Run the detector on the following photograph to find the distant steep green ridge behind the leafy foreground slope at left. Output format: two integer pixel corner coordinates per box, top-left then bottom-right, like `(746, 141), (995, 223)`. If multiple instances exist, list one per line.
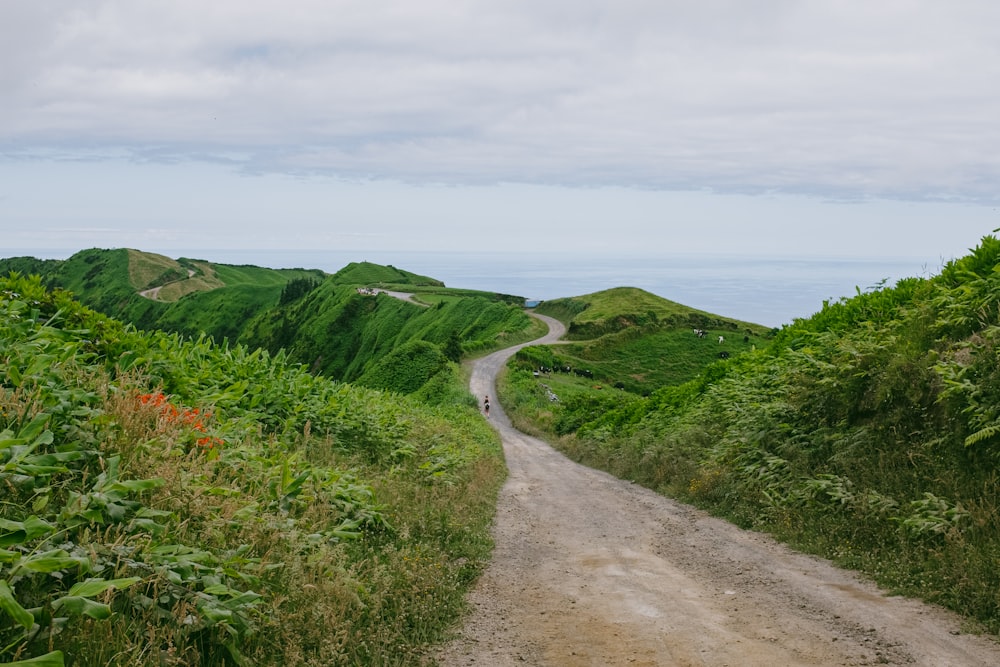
(0, 249), (539, 393)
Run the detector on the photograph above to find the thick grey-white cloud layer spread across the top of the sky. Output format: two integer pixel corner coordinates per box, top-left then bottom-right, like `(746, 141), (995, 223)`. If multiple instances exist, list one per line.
(0, 0), (1000, 201)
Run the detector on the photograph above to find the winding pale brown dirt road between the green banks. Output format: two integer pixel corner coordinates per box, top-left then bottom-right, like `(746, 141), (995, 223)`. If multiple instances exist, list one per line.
(436, 318), (1000, 667)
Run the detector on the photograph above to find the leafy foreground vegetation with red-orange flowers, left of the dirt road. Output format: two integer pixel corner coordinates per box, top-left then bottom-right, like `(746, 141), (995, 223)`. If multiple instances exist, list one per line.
(0, 275), (503, 667)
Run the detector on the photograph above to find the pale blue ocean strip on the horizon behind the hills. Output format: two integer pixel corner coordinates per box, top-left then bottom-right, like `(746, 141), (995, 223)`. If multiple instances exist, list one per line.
(7, 249), (942, 327)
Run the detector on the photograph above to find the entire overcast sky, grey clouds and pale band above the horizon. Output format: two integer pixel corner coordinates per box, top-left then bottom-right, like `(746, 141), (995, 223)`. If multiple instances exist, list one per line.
(0, 0), (1000, 260)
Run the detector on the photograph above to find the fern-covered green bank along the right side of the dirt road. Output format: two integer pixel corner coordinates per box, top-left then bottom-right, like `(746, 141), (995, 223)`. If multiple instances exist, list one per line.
(500, 237), (1000, 632)
